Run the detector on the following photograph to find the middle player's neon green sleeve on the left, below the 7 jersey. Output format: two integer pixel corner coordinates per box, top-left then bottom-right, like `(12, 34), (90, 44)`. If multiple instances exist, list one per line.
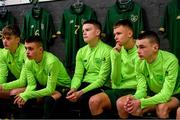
(71, 49), (84, 89)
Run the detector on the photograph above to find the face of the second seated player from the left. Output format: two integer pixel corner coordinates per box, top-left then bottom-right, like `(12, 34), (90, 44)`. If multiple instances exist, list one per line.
(25, 42), (42, 60)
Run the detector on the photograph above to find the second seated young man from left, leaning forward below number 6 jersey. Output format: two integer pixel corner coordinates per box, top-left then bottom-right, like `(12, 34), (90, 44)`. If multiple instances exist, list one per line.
(14, 36), (70, 118)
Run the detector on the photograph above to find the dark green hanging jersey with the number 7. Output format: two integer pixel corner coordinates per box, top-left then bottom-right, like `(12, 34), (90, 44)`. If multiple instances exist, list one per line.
(59, 4), (97, 69)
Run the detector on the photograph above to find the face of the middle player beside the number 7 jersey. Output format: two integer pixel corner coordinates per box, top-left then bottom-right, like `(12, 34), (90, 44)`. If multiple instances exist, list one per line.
(83, 24), (100, 43)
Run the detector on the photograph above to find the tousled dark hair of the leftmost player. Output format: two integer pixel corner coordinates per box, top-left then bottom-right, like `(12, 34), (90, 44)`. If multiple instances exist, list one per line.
(2, 25), (20, 37)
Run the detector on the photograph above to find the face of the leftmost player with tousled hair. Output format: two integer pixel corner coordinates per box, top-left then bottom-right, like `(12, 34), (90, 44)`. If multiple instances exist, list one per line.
(2, 35), (19, 51)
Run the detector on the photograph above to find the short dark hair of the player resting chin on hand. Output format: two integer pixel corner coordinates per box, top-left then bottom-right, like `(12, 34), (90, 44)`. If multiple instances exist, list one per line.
(113, 19), (133, 32)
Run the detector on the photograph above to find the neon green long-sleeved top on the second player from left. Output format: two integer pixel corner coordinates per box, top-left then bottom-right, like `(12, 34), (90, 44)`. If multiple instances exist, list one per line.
(20, 51), (71, 101)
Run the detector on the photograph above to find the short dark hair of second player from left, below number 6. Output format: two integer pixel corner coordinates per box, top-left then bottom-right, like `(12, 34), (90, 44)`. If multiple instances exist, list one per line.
(25, 36), (42, 47)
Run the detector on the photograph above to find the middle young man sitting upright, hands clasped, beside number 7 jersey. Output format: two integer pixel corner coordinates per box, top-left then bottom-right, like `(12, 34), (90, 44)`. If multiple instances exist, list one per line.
(66, 20), (112, 118)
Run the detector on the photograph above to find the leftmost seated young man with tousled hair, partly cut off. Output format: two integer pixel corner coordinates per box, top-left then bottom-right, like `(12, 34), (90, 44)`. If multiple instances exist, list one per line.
(0, 25), (26, 118)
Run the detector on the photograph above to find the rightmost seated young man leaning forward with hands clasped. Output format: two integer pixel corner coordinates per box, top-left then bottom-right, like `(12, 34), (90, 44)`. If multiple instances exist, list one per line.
(118, 31), (179, 118)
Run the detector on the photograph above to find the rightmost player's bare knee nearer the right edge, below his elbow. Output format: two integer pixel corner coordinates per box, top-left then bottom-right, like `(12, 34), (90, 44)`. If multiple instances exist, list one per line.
(156, 103), (169, 118)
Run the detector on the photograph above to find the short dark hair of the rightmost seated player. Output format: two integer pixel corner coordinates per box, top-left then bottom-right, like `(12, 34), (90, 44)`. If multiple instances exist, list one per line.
(137, 31), (160, 47)
